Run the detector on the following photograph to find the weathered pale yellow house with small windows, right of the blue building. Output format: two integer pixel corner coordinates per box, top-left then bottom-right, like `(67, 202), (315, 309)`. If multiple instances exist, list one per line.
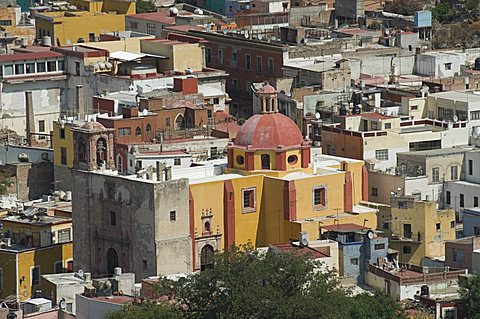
(378, 196), (456, 265)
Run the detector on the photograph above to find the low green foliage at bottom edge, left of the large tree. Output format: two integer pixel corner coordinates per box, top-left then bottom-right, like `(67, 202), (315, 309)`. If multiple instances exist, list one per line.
(105, 302), (182, 319)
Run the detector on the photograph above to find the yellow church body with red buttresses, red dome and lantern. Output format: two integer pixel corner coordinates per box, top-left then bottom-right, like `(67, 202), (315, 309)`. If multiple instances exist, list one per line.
(189, 85), (377, 269)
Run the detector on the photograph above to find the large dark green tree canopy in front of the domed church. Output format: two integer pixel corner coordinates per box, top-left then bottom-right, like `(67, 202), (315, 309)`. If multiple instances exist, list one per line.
(109, 247), (406, 319)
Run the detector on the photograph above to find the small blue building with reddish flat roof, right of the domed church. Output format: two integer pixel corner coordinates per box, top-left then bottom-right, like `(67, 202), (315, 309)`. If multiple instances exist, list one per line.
(321, 224), (388, 283)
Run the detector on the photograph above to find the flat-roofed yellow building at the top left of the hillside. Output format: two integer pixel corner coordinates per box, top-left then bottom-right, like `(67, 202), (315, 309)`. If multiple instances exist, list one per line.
(35, 0), (135, 46)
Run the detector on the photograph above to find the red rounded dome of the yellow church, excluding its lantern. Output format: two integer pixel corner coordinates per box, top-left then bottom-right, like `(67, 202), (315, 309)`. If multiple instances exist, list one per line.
(234, 113), (303, 149)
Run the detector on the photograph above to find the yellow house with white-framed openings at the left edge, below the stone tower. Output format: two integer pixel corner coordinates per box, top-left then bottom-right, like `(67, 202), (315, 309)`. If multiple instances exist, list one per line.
(0, 208), (73, 301)
